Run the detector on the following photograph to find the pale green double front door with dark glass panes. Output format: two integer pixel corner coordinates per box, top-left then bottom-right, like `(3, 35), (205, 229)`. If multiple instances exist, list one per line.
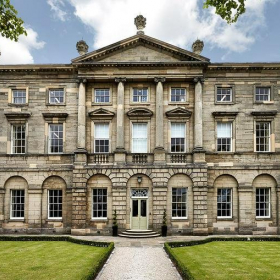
(131, 198), (148, 230)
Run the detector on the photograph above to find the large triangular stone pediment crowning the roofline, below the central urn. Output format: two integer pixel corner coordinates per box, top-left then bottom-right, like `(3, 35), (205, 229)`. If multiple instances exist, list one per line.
(72, 35), (209, 64)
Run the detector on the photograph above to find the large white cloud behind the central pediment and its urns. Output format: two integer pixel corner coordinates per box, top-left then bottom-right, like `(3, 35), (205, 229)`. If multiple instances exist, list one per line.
(64, 0), (275, 55)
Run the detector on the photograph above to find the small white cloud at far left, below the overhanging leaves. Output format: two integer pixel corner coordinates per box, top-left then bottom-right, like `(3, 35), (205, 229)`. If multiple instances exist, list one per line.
(0, 28), (45, 64)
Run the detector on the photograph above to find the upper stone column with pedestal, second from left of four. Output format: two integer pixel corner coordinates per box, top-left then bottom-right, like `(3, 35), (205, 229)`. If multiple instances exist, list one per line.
(115, 78), (126, 163)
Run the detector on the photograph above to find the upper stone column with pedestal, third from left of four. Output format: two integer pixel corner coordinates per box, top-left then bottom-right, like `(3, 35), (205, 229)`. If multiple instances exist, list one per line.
(154, 77), (165, 164)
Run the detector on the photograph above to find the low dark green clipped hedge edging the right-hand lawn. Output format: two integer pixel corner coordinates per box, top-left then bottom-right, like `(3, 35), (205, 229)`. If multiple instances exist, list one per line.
(164, 236), (280, 280)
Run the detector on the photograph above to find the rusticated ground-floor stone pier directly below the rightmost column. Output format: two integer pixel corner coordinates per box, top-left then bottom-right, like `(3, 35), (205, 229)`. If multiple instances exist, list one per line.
(192, 168), (208, 235)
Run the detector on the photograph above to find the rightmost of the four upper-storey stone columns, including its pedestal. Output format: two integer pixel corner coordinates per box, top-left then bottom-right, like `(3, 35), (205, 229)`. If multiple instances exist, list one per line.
(193, 78), (205, 163)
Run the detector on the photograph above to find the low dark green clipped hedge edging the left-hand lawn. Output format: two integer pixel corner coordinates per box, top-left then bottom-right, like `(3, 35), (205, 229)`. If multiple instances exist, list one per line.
(0, 235), (114, 280)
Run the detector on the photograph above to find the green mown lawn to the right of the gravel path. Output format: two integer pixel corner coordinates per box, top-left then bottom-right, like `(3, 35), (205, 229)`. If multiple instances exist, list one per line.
(171, 241), (280, 280)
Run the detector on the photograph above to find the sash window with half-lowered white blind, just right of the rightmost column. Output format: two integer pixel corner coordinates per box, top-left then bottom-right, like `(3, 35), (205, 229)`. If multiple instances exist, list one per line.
(217, 122), (232, 152)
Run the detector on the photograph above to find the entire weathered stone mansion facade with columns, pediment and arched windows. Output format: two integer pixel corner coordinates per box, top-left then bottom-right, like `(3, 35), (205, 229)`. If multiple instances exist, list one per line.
(0, 18), (280, 235)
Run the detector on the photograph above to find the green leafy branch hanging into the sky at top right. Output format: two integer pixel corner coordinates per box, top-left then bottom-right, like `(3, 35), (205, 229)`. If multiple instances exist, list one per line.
(203, 0), (246, 23)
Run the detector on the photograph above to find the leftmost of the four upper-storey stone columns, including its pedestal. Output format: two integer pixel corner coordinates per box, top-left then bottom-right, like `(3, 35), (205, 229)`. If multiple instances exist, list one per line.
(75, 79), (87, 164)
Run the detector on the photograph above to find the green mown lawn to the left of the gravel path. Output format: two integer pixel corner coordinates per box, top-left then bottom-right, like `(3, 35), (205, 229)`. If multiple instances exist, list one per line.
(0, 241), (108, 280)
